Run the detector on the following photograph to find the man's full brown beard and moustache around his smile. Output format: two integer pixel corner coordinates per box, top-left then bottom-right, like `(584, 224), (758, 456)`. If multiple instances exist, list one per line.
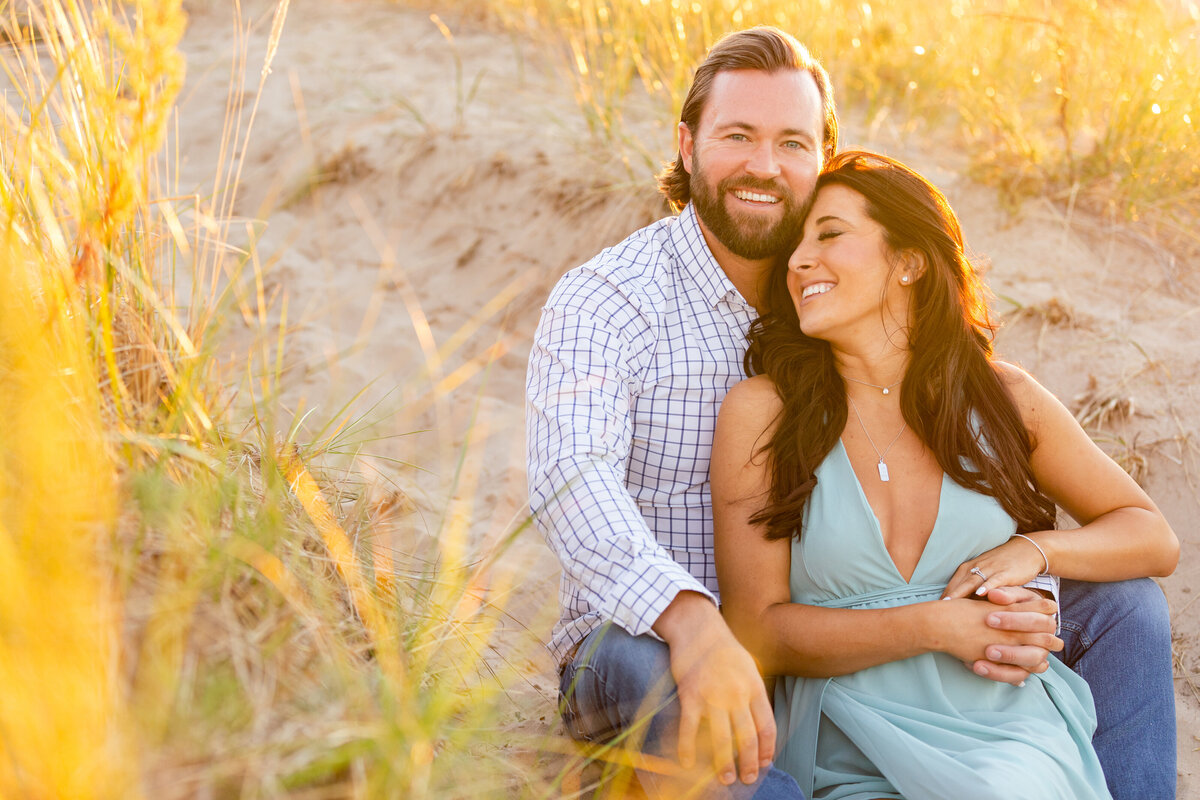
(689, 152), (806, 261)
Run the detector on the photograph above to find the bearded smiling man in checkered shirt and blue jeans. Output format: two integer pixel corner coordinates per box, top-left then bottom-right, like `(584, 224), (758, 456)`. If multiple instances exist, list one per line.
(527, 28), (1175, 798)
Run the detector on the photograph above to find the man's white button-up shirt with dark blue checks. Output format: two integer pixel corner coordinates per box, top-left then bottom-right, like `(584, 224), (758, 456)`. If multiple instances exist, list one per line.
(526, 205), (1057, 662)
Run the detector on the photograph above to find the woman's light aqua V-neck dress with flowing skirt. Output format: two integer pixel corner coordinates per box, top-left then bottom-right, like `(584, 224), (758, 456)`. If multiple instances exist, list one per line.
(775, 440), (1110, 800)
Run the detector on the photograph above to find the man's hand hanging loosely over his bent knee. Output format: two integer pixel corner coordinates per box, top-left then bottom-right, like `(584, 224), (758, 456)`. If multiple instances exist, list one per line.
(654, 591), (775, 786)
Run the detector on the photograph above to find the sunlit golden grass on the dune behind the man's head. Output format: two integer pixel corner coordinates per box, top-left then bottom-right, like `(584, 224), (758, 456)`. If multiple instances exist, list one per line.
(472, 0), (1200, 260)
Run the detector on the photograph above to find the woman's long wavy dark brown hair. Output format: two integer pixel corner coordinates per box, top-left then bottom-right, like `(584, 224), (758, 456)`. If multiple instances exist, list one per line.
(745, 151), (1055, 539)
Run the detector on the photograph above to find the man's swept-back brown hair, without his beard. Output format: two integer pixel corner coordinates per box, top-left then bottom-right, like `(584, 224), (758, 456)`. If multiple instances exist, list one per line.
(659, 25), (838, 211)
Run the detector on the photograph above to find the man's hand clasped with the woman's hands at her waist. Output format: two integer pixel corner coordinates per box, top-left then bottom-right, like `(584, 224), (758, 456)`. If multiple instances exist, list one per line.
(950, 587), (1063, 685)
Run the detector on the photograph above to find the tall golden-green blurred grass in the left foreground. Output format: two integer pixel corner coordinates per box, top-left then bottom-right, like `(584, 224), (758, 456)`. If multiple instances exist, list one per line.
(0, 0), (556, 800)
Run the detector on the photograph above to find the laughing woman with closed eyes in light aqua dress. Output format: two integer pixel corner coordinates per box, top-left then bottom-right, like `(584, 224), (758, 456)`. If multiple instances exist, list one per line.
(712, 152), (1178, 800)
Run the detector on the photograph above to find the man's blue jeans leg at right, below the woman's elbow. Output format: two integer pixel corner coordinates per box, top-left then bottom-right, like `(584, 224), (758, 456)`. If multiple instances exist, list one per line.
(1058, 578), (1176, 800)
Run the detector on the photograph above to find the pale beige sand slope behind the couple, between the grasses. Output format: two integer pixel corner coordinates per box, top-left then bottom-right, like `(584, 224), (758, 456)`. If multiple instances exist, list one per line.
(179, 0), (1200, 798)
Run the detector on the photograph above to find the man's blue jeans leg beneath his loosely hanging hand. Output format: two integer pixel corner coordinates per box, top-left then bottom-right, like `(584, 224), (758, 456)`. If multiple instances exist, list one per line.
(559, 625), (804, 800)
